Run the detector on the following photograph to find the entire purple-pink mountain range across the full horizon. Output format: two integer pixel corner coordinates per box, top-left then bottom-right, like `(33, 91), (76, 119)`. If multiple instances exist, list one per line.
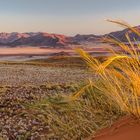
(0, 26), (140, 47)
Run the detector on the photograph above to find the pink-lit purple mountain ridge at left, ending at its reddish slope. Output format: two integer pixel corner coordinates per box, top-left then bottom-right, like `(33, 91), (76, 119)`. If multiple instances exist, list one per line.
(0, 32), (74, 47)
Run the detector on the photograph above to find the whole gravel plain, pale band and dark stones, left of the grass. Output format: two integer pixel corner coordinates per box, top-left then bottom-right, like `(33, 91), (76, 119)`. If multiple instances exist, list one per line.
(0, 64), (92, 140)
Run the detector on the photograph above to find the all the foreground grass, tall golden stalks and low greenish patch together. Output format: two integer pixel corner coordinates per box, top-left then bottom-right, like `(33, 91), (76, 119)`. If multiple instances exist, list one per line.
(26, 21), (140, 140)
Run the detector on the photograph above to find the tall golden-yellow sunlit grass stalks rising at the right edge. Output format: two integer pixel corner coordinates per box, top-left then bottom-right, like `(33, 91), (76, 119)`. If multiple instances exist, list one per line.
(77, 20), (140, 118)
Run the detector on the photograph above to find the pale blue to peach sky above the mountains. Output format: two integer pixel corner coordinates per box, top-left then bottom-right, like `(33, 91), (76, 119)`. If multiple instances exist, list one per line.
(0, 0), (140, 36)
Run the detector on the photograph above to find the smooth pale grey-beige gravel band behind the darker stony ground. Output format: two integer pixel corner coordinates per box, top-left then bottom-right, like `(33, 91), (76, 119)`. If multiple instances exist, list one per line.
(0, 64), (92, 86)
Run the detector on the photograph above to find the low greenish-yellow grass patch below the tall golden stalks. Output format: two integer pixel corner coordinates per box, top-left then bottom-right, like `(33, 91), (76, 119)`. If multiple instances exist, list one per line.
(27, 83), (123, 140)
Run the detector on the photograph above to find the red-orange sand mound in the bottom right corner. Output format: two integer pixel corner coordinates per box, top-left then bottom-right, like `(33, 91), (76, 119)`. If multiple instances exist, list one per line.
(94, 116), (140, 140)
